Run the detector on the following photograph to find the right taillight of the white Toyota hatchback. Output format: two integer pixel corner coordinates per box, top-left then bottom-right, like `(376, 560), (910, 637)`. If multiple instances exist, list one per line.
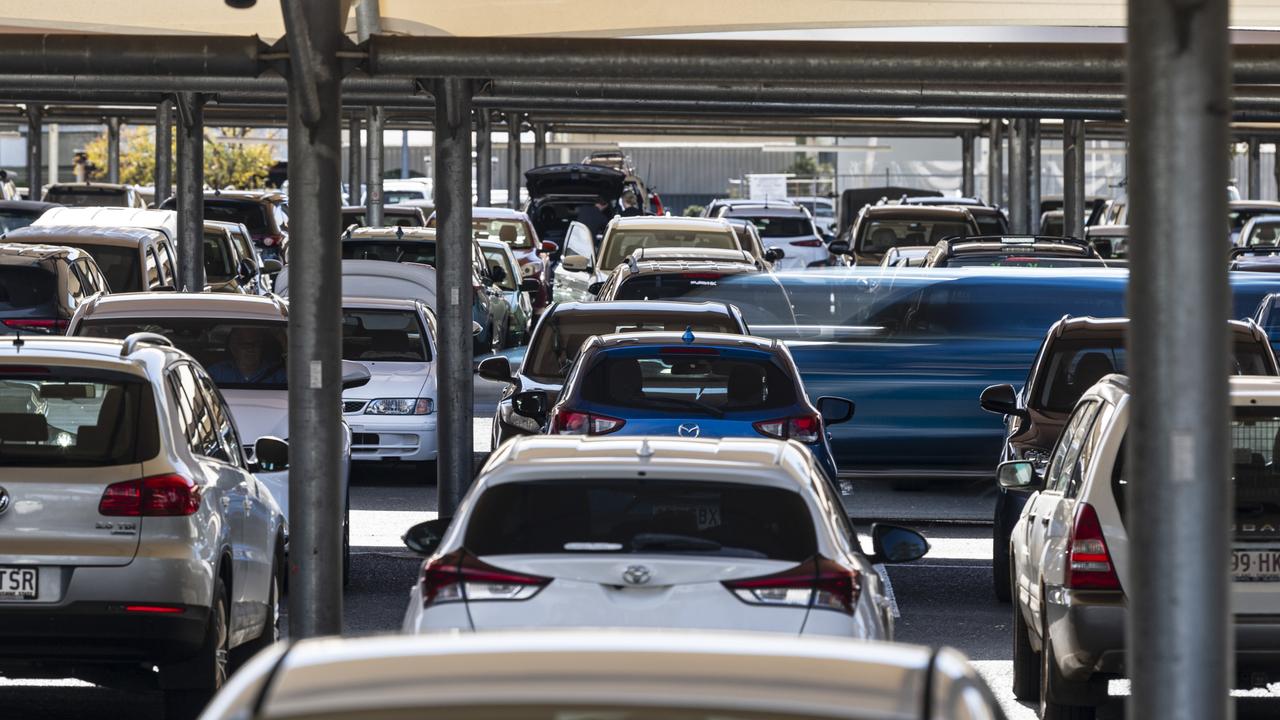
(721, 555), (863, 615)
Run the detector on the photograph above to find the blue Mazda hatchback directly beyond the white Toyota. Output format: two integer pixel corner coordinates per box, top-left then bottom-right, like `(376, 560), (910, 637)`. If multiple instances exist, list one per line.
(512, 331), (854, 482)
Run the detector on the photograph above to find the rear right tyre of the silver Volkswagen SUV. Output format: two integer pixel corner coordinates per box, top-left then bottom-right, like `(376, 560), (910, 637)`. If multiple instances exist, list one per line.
(161, 578), (232, 720)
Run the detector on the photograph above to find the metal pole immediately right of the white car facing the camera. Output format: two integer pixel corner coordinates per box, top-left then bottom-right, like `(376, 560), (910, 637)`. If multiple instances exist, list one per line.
(433, 78), (473, 518)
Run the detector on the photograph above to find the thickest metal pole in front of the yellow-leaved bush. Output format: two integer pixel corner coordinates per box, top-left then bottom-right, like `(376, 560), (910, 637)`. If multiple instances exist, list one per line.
(178, 92), (205, 292)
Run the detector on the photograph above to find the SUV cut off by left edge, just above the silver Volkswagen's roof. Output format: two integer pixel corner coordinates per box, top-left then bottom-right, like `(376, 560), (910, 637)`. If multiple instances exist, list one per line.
(0, 243), (110, 334)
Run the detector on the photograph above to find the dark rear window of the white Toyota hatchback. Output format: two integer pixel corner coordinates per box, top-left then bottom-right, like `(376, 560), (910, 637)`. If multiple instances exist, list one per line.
(463, 478), (817, 561)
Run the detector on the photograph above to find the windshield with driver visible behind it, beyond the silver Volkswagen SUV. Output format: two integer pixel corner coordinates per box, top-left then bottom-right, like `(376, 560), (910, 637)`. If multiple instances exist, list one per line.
(76, 318), (289, 389)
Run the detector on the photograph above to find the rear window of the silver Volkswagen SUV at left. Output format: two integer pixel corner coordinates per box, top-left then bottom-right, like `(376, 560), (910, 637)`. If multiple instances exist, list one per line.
(0, 368), (160, 466)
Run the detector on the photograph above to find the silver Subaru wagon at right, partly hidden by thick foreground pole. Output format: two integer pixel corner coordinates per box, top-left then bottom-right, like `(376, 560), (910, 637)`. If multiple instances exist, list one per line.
(998, 375), (1280, 719)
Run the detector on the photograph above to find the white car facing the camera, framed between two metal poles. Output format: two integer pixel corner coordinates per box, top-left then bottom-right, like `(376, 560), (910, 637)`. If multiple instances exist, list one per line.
(342, 294), (439, 462)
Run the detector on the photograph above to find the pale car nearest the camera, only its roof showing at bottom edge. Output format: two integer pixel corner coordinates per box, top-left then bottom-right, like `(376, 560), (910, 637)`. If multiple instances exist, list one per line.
(205, 630), (1005, 720)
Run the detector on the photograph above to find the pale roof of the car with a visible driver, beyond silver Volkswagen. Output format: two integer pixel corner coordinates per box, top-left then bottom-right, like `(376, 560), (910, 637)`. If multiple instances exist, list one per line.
(81, 292), (289, 320)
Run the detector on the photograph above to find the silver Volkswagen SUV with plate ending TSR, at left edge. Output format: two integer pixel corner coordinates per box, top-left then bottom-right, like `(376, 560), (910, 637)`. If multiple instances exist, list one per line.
(0, 333), (288, 717)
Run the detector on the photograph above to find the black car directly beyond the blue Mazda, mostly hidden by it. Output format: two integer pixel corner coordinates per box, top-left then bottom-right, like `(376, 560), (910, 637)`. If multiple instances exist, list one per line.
(476, 301), (748, 447)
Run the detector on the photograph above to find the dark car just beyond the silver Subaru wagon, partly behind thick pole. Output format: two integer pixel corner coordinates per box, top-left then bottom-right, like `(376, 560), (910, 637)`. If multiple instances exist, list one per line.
(979, 318), (1277, 602)
